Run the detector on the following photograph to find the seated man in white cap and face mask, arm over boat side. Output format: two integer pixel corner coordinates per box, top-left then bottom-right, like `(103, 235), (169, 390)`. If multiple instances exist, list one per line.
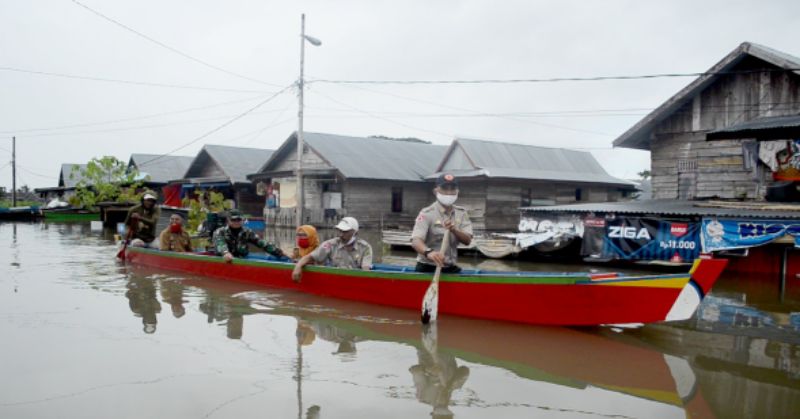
(292, 217), (372, 282)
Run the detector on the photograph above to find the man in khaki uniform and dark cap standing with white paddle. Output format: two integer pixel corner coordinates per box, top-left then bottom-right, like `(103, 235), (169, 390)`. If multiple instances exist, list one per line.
(411, 173), (472, 273)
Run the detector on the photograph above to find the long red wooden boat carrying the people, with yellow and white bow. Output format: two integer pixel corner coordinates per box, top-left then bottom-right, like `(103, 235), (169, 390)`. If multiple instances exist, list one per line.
(126, 247), (727, 325)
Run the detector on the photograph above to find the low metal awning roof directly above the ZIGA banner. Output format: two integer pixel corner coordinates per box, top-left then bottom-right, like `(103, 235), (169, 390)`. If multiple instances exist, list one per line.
(522, 199), (800, 219)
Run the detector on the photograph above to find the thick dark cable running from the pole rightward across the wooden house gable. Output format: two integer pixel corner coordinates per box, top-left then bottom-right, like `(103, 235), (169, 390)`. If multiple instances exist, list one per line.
(306, 68), (800, 84)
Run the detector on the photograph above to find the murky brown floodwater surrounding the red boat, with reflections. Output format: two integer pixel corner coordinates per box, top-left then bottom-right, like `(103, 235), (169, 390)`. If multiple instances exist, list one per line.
(0, 223), (800, 419)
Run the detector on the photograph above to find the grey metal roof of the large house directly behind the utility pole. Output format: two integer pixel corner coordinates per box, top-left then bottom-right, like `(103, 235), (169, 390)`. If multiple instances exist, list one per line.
(303, 132), (447, 182)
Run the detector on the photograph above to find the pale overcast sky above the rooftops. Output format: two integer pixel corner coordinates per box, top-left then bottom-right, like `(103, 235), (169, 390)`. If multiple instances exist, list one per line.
(0, 0), (800, 187)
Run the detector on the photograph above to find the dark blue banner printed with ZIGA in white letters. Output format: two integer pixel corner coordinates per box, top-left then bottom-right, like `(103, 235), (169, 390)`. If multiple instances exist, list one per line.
(603, 217), (700, 262)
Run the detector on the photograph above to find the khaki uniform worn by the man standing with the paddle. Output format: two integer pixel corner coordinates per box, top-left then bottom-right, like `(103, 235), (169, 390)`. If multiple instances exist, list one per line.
(411, 202), (472, 266)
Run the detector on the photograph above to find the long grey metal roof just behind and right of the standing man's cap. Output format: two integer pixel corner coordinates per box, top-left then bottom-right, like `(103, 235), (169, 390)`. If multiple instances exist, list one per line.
(429, 138), (634, 187)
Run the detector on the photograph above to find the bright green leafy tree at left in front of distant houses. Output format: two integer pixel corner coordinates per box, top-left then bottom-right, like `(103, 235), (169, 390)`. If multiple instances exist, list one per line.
(70, 156), (148, 210)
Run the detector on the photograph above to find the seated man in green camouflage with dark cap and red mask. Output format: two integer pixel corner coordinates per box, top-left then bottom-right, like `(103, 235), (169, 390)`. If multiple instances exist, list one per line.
(211, 210), (284, 262)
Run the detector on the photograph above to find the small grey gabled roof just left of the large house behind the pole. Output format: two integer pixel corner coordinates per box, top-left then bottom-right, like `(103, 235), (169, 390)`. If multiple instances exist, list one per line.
(185, 144), (274, 183)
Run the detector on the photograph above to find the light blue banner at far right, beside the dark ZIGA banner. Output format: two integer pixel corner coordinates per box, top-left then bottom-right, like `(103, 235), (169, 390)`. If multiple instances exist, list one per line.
(702, 218), (800, 252)
